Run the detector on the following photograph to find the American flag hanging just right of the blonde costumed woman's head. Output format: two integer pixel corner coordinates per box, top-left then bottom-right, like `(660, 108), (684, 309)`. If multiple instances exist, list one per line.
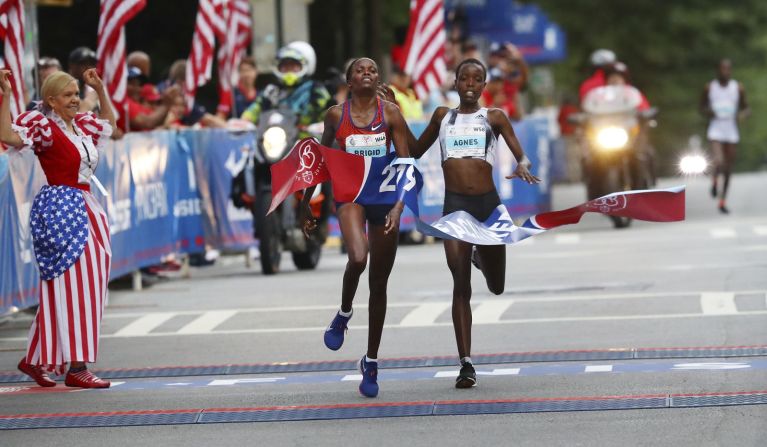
(96, 0), (146, 122)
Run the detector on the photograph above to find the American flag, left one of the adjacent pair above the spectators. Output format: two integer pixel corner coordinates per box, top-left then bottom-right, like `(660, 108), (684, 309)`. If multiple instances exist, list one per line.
(184, 0), (228, 109)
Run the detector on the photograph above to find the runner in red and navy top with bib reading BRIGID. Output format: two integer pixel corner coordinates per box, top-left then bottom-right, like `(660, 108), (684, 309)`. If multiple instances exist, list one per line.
(303, 58), (412, 397)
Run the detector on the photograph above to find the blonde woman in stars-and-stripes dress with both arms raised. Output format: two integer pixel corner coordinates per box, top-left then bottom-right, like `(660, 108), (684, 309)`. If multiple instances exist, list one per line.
(0, 69), (115, 388)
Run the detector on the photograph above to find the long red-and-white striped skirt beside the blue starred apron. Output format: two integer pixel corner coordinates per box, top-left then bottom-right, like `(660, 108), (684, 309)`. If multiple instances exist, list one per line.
(26, 191), (112, 374)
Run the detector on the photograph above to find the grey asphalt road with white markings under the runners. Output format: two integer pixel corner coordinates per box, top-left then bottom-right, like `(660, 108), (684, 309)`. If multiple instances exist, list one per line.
(0, 173), (767, 446)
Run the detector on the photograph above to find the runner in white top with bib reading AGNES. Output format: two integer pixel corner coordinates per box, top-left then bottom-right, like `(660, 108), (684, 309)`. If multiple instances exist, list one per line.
(410, 59), (540, 388)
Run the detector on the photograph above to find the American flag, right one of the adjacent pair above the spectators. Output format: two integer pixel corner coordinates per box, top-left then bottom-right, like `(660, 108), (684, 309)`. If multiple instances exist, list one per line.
(216, 0), (252, 117)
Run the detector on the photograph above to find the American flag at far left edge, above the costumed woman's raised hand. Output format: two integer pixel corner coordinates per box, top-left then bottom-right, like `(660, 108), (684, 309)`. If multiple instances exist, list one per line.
(0, 0), (26, 116)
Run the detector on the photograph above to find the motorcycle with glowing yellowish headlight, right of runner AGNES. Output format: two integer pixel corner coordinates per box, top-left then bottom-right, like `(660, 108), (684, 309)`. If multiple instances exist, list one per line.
(568, 85), (657, 228)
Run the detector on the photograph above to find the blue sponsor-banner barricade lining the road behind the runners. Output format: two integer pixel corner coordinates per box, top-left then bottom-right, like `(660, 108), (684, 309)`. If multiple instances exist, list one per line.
(0, 118), (551, 315)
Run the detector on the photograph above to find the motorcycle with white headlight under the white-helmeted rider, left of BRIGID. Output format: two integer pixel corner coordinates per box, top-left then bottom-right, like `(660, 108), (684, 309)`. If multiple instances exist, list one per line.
(232, 106), (331, 275)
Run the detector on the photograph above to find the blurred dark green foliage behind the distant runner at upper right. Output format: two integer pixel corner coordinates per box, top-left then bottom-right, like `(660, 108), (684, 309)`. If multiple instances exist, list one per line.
(532, 0), (767, 170)
